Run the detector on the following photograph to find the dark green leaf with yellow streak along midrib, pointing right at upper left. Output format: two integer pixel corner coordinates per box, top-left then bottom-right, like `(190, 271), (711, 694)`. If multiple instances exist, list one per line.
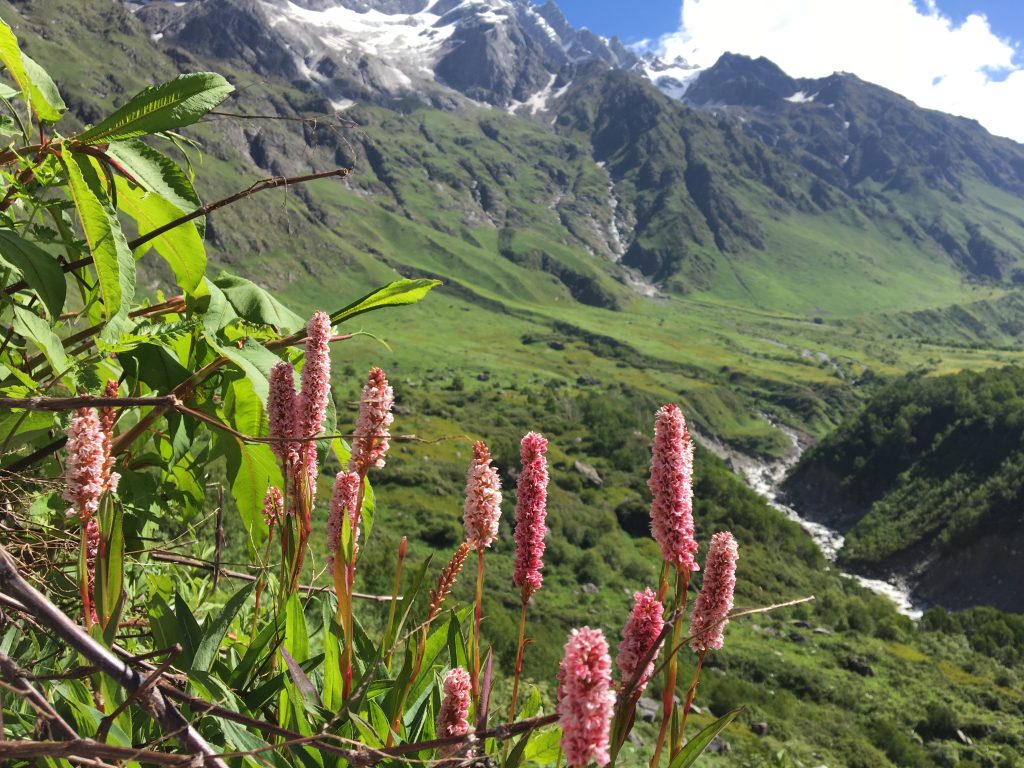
(76, 72), (234, 144)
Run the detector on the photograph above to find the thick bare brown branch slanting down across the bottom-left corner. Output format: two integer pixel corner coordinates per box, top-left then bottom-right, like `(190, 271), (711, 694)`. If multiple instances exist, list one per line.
(0, 547), (227, 768)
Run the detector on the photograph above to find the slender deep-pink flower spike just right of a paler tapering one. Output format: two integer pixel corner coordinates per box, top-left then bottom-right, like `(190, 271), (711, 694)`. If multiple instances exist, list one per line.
(512, 432), (548, 600)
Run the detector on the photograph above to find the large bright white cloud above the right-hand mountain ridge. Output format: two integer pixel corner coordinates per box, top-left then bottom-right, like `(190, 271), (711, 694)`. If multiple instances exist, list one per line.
(656, 0), (1024, 141)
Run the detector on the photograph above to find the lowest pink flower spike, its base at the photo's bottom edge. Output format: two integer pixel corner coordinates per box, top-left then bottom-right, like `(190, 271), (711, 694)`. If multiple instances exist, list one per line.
(558, 627), (615, 768)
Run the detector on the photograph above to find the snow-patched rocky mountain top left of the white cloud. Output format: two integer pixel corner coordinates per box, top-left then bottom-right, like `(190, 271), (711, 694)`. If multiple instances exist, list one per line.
(129, 0), (641, 112)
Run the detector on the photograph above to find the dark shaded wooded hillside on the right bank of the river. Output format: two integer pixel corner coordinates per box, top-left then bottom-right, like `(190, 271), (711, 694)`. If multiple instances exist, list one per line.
(786, 368), (1024, 611)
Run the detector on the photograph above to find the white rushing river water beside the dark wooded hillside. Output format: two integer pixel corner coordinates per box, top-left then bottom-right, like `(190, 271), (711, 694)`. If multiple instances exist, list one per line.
(701, 424), (927, 621)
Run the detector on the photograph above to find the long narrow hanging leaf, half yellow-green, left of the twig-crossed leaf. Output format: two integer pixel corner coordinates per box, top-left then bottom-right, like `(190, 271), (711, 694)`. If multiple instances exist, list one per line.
(61, 153), (135, 318)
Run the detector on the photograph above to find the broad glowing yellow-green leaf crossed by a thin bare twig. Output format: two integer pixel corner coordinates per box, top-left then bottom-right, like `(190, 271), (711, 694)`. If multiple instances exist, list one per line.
(115, 176), (206, 293)
